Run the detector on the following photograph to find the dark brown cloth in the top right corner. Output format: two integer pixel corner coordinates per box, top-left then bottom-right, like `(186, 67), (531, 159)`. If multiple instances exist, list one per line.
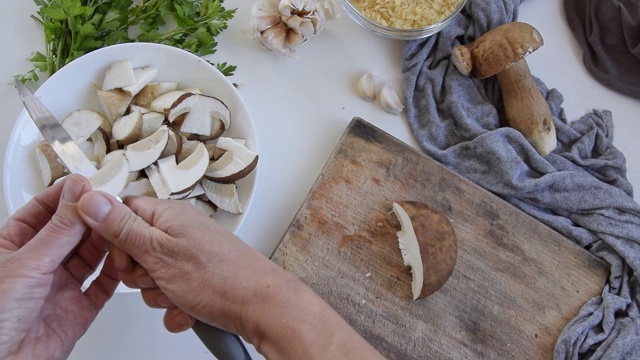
(564, 0), (640, 99)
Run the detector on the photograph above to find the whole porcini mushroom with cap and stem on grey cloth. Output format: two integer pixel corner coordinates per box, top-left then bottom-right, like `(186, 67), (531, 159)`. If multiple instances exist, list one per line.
(451, 22), (557, 156)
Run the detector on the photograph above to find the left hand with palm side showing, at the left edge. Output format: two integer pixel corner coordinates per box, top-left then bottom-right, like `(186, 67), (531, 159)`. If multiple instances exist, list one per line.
(0, 175), (119, 359)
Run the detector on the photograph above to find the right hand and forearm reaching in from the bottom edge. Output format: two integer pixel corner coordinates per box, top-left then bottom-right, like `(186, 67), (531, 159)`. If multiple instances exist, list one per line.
(78, 191), (382, 360)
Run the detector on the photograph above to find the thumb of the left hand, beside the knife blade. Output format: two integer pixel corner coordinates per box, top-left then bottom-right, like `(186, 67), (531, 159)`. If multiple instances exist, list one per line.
(20, 175), (91, 271)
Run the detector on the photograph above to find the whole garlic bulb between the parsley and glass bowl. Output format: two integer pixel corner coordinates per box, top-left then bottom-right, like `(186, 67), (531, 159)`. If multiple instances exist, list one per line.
(251, 0), (336, 56)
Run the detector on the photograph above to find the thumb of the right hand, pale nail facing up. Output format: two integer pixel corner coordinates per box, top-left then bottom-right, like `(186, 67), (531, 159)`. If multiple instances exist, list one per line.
(78, 191), (164, 266)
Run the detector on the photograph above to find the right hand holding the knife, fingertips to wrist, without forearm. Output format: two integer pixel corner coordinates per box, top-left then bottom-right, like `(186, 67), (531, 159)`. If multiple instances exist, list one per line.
(79, 192), (286, 335)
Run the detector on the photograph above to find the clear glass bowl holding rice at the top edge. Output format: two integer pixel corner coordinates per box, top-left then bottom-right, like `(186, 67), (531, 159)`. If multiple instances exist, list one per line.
(339, 0), (467, 40)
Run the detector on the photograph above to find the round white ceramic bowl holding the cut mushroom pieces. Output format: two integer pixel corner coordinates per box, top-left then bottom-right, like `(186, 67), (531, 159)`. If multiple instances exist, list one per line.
(3, 43), (259, 290)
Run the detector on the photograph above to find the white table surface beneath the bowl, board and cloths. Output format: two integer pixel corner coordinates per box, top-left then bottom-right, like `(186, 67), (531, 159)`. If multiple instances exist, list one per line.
(0, 0), (640, 360)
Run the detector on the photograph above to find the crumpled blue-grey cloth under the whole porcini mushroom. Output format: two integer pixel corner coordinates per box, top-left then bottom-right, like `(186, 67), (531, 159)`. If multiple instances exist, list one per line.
(402, 0), (640, 359)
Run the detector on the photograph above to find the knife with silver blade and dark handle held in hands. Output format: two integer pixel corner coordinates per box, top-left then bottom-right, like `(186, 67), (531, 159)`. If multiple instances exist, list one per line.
(15, 78), (251, 360)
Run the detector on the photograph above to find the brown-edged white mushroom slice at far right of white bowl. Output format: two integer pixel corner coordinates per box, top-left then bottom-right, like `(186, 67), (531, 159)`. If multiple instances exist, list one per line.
(205, 137), (258, 184)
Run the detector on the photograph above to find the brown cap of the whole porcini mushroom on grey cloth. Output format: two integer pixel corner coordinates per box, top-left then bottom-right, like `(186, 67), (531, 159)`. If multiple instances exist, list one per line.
(452, 22), (544, 79)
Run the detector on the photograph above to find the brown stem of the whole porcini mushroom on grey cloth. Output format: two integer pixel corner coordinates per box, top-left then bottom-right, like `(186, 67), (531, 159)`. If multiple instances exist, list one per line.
(497, 58), (557, 156)
